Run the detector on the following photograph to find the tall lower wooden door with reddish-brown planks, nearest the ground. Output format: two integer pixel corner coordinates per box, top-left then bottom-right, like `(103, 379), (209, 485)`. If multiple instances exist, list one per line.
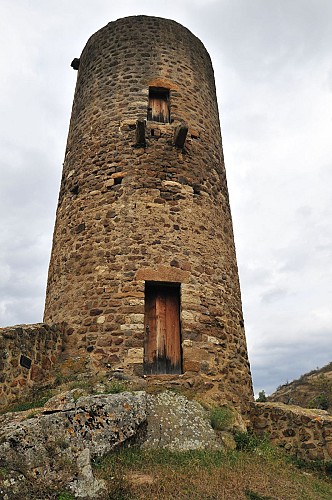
(144, 284), (181, 374)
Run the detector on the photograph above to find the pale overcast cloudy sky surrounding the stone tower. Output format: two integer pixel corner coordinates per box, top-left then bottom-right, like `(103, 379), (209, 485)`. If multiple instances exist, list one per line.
(0, 0), (332, 393)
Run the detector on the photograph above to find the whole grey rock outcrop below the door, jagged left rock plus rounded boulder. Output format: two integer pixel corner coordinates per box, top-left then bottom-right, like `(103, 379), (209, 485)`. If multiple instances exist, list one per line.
(0, 389), (220, 500)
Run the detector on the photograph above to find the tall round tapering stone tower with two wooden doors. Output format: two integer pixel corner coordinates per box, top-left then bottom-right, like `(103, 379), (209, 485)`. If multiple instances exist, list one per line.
(44, 16), (252, 404)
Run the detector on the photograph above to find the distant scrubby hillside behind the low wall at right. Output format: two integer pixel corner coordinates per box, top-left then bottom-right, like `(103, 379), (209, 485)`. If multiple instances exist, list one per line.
(267, 362), (332, 414)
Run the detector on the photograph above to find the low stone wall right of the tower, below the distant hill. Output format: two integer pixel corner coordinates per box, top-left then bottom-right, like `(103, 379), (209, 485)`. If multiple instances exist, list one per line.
(250, 403), (332, 461)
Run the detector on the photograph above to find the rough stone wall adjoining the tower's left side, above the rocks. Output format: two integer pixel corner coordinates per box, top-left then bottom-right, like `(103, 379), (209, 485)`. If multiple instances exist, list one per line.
(0, 323), (64, 408)
